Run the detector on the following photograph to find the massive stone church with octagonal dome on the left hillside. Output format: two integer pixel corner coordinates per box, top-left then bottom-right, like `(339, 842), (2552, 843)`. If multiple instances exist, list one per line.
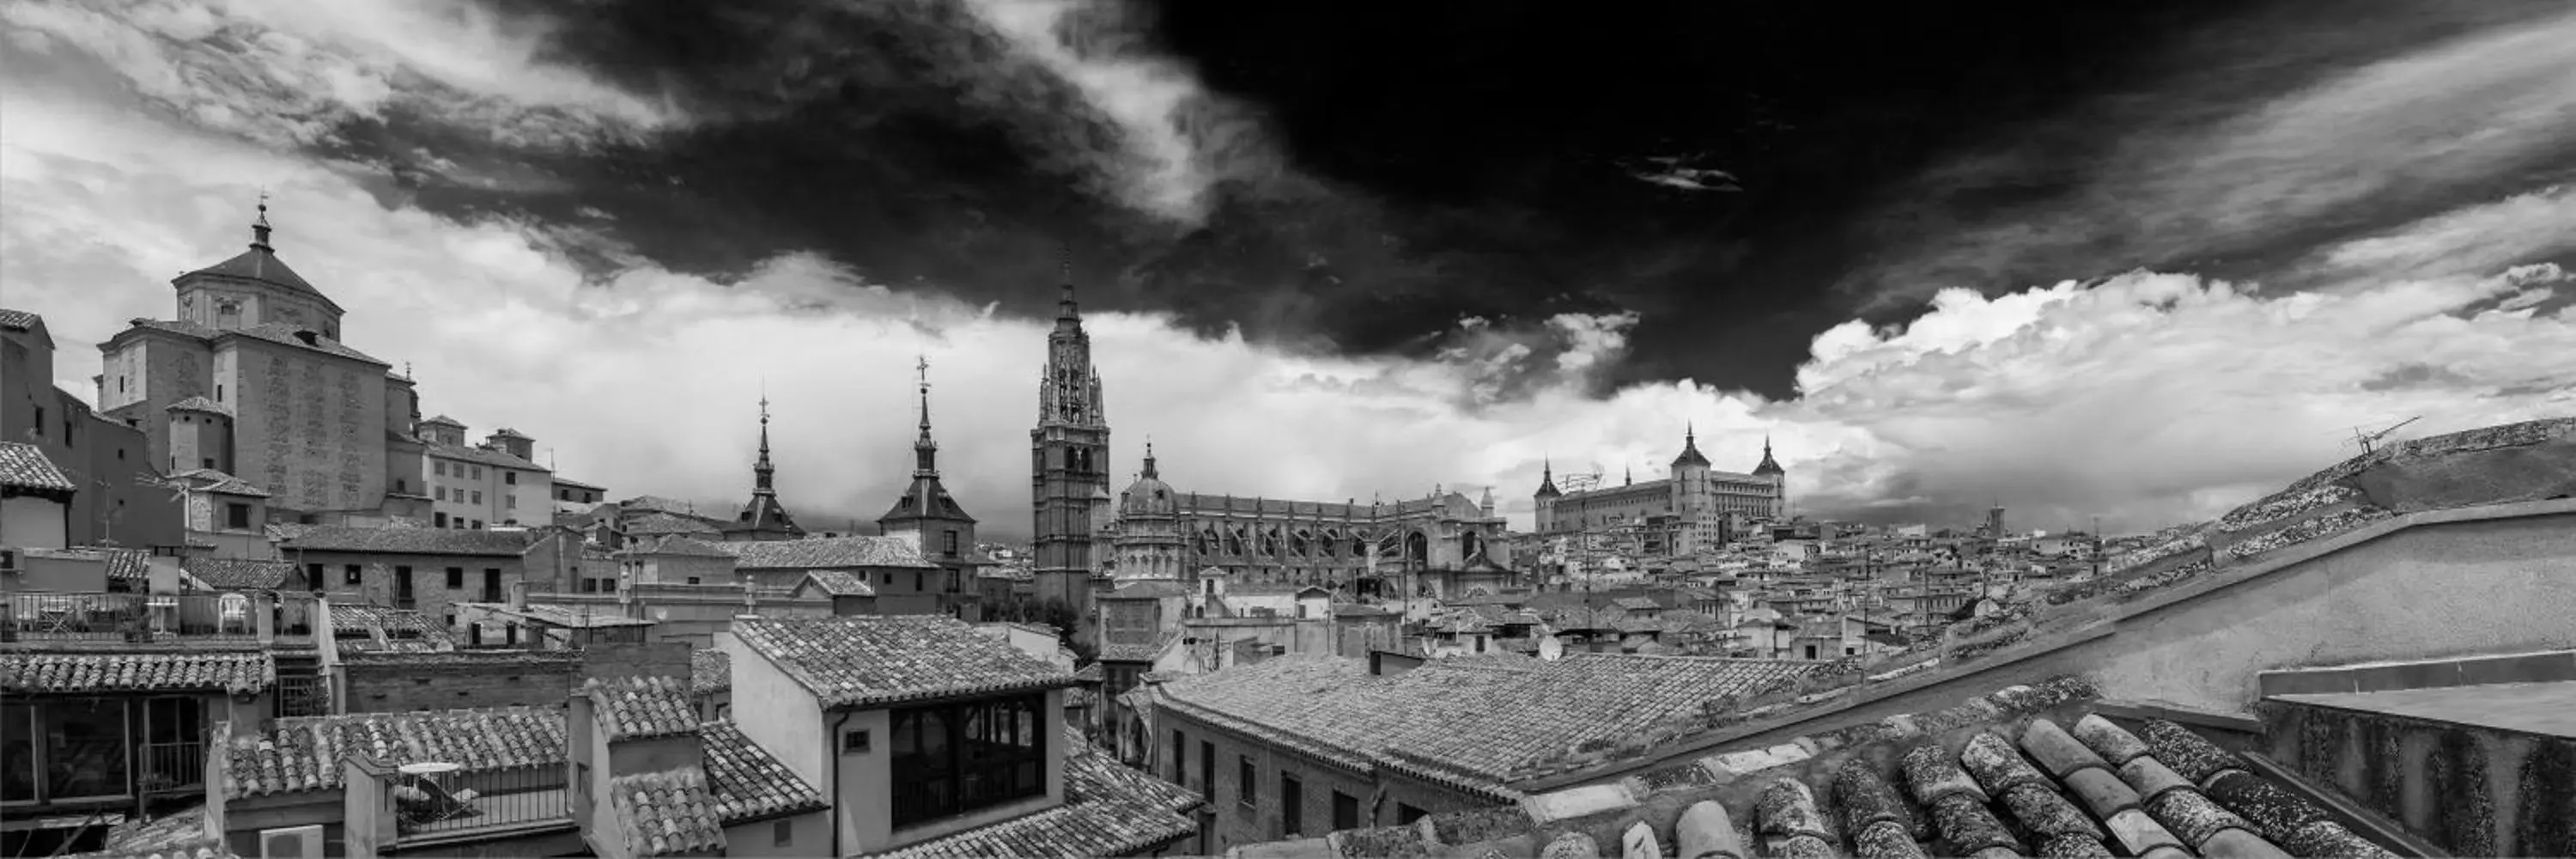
(95, 204), (580, 529)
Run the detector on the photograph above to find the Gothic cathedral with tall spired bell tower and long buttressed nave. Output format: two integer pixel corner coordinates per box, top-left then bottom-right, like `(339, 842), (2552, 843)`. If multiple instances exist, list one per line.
(1030, 260), (1510, 604)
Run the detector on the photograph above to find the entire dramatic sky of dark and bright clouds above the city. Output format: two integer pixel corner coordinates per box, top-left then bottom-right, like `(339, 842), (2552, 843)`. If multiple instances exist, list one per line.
(0, 0), (2576, 537)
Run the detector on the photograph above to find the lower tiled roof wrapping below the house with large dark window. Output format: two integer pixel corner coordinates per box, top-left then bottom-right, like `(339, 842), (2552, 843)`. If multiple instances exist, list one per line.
(881, 730), (1200, 859)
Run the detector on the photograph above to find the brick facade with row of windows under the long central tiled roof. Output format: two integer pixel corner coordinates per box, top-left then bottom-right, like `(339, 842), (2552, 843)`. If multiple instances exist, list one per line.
(1151, 710), (1497, 854)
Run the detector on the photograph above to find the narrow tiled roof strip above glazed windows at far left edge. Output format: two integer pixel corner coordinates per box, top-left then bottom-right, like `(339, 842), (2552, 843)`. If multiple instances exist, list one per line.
(0, 650), (278, 694)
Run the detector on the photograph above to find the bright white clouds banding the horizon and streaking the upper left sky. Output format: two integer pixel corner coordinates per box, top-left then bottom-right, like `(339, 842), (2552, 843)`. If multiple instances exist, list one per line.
(0, 3), (2576, 534)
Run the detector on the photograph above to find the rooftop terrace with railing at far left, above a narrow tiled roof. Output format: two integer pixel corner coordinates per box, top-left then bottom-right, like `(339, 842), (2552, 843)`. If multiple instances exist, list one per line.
(0, 591), (317, 643)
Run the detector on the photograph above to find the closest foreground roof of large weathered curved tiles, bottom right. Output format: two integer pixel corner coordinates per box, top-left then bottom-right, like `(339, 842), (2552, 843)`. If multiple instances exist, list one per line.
(1288, 679), (2391, 859)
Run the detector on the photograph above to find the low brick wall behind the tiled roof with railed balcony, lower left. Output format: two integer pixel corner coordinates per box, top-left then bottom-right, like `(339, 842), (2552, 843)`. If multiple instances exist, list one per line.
(345, 650), (580, 712)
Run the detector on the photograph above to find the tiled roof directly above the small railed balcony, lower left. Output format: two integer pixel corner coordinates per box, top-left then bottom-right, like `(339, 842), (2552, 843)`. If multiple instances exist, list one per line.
(224, 707), (564, 797)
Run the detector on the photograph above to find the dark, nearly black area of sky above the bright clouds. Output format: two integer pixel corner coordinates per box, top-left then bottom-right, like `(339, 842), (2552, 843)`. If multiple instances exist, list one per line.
(282, 0), (2318, 394)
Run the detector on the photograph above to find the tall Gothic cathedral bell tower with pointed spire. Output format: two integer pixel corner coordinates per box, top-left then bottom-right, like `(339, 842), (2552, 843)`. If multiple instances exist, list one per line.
(1028, 250), (1110, 612)
